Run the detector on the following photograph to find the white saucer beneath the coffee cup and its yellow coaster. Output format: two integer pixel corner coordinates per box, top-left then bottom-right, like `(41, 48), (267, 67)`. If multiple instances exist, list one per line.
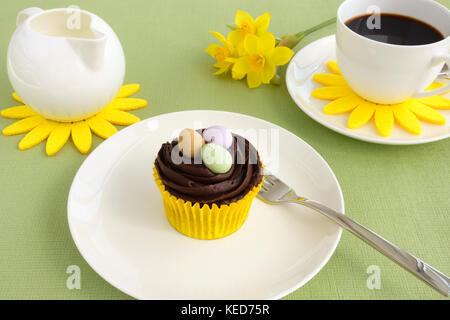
(286, 35), (450, 145)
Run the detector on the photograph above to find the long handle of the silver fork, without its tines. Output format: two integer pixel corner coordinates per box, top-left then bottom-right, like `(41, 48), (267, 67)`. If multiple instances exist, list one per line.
(296, 199), (450, 297)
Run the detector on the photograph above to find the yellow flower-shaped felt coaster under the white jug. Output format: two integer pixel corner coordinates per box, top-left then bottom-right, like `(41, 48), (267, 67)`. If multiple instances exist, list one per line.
(0, 84), (147, 156)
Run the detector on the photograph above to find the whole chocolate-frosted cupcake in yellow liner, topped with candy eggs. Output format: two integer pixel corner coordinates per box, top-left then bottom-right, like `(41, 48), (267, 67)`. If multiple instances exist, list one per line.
(153, 126), (263, 239)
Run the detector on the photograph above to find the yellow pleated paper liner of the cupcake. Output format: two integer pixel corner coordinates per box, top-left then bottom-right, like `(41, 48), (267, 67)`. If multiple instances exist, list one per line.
(153, 168), (262, 240)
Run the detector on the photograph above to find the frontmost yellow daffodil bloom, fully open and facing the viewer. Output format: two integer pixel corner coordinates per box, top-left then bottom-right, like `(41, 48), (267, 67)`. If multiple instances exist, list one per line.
(226, 32), (294, 88)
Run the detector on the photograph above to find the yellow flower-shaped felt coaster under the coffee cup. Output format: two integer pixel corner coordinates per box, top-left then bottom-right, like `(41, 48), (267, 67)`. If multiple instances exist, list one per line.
(311, 61), (450, 137)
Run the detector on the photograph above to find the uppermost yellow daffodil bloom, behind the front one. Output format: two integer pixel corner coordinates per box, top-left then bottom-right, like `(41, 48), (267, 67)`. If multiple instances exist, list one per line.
(229, 10), (270, 55)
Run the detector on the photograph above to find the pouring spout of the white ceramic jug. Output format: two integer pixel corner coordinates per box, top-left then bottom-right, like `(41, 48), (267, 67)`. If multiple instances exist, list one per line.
(67, 31), (106, 71)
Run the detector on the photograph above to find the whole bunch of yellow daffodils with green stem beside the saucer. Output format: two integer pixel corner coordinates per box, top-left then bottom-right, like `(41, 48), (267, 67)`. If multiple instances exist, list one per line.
(206, 10), (336, 88)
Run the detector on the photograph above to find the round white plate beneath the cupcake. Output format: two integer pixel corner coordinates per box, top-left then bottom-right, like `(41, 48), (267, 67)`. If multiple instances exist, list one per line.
(68, 111), (344, 299)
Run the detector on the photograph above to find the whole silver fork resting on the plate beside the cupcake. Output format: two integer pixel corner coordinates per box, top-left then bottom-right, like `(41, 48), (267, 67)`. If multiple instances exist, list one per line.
(257, 174), (450, 297)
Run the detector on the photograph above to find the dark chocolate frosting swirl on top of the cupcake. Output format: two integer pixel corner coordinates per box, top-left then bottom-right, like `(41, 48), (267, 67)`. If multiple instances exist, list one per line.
(155, 129), (262, 206)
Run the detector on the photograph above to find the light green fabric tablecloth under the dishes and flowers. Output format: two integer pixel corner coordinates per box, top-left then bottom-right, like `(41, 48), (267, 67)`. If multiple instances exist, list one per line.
(0, 0), (450, 299)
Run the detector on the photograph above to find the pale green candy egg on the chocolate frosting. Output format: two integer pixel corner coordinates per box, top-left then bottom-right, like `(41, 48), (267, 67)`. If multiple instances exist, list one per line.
(202, 143), (233, 173)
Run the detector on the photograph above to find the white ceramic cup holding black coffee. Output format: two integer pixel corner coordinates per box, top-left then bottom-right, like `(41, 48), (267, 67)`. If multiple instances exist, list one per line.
(336, 0), (450, 104)
